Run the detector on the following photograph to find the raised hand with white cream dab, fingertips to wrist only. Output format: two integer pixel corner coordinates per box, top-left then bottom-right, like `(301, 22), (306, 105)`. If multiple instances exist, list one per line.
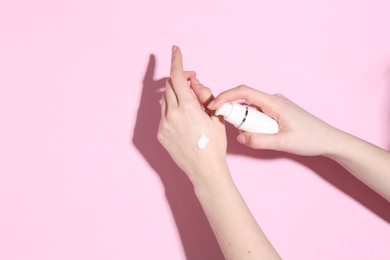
(157, 46), (227, 184)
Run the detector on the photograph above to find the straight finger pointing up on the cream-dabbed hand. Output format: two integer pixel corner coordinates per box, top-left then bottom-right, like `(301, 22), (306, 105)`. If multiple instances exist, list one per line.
(170, 46), (195, 103)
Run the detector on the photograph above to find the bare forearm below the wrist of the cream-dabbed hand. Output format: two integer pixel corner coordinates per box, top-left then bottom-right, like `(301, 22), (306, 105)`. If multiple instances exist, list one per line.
(194, 162), (280, 259)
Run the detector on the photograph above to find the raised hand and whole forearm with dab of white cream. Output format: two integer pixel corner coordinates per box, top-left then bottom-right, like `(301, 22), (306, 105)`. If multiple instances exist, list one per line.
(158, 47), (280, 259)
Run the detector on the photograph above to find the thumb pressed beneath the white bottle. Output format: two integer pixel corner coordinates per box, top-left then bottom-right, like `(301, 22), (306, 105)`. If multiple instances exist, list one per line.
(237, 132), (279, 150)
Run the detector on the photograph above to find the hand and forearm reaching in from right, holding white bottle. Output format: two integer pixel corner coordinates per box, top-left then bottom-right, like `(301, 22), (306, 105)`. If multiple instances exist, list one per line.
(208, 86), (390, 201)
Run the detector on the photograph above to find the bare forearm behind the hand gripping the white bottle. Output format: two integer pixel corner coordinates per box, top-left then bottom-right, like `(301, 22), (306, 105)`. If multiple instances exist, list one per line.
(325, 130), (390, 201)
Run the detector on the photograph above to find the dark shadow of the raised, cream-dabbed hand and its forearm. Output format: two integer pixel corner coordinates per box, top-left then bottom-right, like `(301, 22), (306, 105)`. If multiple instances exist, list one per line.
(132, 55), (224, 260)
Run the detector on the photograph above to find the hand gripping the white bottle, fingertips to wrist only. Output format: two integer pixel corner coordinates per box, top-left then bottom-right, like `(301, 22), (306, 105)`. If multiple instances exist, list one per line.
(208, 85), (339, 156)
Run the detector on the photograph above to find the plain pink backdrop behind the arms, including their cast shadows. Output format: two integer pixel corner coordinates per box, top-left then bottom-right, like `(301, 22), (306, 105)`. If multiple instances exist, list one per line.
(0, 0), (390, 260)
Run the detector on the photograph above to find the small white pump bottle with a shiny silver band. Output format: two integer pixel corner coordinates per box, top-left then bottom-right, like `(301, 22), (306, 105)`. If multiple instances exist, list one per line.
(215, 103), (279, 134)
